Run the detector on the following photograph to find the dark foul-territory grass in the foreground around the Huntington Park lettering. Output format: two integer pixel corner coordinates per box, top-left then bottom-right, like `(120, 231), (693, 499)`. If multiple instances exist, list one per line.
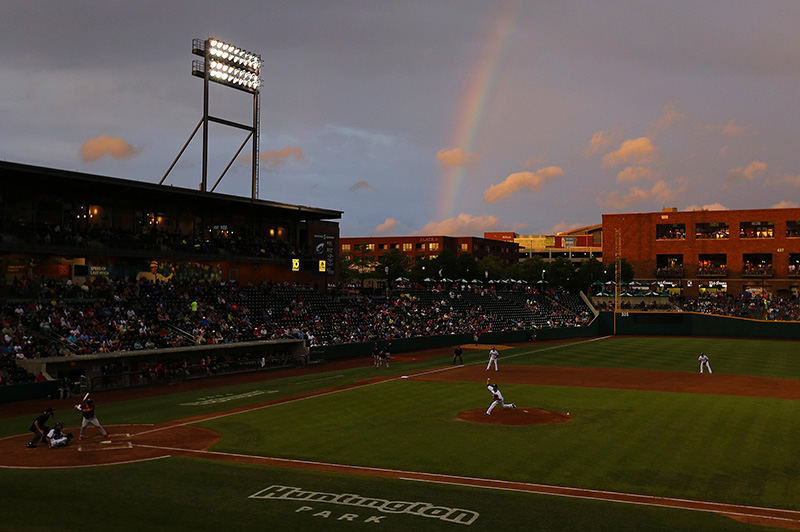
(0, 458), (768, 532)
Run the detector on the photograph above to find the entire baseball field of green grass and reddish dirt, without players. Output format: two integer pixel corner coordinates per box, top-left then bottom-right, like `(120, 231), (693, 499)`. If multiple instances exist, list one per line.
(0, 337), (800, 532)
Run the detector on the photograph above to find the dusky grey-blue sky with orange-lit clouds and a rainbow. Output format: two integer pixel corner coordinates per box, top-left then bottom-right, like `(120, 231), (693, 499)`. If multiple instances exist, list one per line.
(0, 0), (800, 236)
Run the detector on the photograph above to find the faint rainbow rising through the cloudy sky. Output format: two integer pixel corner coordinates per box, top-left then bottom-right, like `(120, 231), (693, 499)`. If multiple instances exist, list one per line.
(436, 0), (520, 220)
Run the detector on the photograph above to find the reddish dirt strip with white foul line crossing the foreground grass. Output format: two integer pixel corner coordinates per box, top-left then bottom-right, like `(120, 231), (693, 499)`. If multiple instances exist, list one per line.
(136, 444), (800, 523)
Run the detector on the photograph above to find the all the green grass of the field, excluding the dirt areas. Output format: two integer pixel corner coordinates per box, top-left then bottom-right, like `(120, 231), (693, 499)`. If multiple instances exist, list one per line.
(0, 338), (800, 531)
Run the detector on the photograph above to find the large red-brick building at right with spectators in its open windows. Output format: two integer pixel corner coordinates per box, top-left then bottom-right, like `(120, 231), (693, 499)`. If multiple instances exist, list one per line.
(603, 208), (800, 296)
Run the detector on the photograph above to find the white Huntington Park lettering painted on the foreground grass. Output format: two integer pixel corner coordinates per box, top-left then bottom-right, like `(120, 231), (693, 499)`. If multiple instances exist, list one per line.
(249, 486), (480, 525)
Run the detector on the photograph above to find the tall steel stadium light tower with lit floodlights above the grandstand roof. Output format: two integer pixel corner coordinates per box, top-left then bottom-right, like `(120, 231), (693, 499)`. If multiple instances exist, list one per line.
(159, 37), (262, 199)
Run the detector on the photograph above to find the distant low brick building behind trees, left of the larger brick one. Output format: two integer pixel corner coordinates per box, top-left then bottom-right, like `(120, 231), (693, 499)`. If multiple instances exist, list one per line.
(339, 236), (519, 266)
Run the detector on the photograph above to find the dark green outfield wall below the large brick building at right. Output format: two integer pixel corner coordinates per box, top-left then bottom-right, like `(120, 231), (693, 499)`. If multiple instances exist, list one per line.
(596, 311), (800, 339)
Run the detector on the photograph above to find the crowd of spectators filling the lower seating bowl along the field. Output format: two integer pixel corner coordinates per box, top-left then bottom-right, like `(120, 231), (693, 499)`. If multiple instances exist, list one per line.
(0, 277), (590, 382)
